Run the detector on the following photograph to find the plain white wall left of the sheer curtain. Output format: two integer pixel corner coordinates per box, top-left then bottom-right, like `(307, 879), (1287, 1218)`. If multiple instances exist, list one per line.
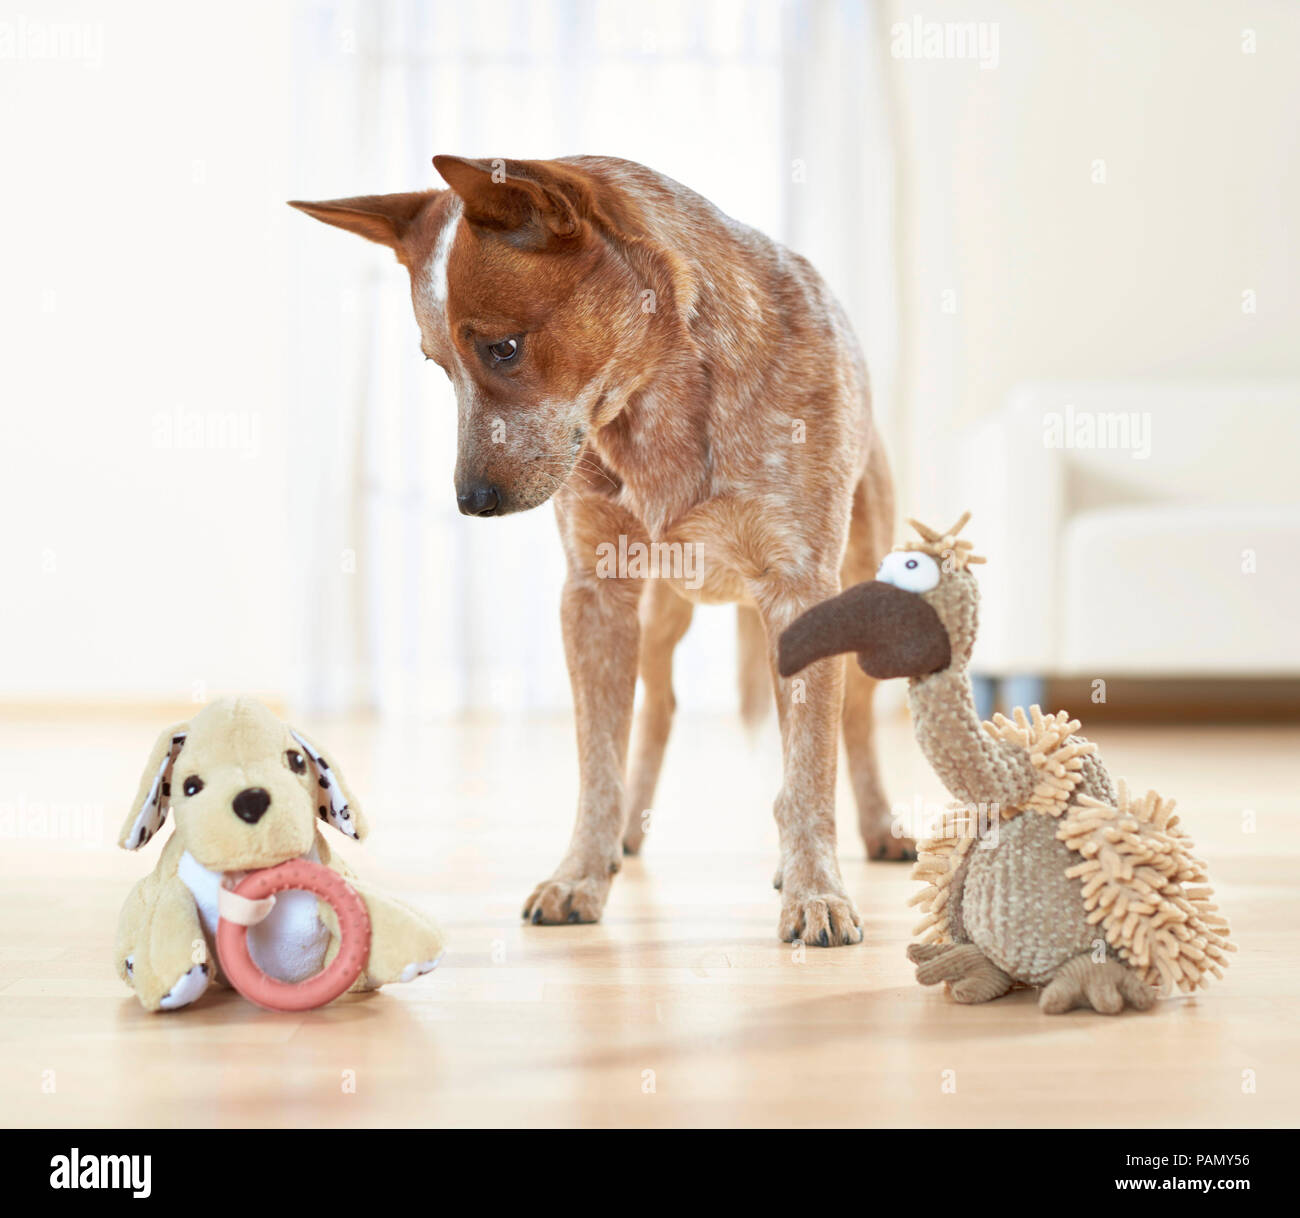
(0, 0), (302, 702)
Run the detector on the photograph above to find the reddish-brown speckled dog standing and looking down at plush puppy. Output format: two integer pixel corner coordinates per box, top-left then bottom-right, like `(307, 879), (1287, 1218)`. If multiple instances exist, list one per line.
(293, 156), (913, 946)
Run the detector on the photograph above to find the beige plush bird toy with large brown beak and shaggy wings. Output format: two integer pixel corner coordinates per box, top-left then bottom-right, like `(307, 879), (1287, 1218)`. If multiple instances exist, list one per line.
(780, 512), (1235, 1014)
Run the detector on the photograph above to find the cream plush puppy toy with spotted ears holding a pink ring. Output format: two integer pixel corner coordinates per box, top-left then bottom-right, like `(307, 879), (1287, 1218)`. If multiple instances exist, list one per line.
(114, 698), (442, 1011)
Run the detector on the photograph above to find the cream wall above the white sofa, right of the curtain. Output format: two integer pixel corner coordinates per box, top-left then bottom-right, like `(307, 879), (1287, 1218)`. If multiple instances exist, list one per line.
(885, 0), (1300, 517)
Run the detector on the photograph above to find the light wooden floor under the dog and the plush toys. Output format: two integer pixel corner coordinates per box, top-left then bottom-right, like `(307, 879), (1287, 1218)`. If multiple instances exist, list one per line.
(0, 716), (1300, 1127)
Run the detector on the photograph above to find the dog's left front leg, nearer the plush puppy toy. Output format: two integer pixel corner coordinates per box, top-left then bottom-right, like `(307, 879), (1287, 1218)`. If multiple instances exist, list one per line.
(524, 569), (642, 924)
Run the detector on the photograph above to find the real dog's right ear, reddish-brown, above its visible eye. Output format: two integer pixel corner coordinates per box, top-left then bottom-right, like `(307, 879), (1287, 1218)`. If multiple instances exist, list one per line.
(433, 156), (581, 246)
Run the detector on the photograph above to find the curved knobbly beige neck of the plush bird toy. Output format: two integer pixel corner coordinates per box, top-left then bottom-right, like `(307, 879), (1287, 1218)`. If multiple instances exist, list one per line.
(907, 667), (1035, 809)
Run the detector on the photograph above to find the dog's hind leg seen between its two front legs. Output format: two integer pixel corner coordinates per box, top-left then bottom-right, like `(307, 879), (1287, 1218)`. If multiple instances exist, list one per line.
(623, 580), (694, 854)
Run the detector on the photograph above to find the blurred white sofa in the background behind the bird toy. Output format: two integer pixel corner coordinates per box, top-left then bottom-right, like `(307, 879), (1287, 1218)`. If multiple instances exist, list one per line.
(954, 374), (1300, 705)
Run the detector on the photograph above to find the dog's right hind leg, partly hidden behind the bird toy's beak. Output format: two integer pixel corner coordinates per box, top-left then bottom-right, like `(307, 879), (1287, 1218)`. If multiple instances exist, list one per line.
(840, 443), (917, 859)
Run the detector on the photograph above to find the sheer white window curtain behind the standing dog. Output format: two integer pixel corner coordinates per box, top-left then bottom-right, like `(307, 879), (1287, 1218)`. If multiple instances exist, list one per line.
(291, 0), (894, 715)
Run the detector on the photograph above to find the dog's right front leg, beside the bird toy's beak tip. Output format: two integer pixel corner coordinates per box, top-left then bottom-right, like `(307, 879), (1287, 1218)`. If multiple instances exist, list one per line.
(757, 582), (862, 948)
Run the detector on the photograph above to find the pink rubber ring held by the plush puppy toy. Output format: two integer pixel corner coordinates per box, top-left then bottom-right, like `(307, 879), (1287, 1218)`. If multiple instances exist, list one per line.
(217, 858), (371, 1011)
